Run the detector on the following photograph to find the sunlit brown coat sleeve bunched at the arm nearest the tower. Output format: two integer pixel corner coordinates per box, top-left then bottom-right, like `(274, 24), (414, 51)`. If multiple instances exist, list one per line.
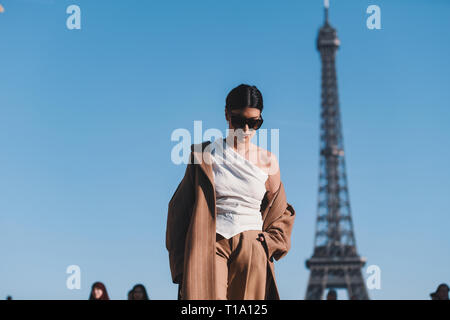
(262, 203), (295, 261)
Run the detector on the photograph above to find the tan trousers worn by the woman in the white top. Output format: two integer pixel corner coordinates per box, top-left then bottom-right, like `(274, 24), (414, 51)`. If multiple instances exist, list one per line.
(215, 230), (267, 300)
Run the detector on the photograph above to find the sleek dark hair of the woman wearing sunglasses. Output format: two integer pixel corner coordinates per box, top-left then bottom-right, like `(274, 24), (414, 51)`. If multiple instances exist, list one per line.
(225, 84), (264, 112)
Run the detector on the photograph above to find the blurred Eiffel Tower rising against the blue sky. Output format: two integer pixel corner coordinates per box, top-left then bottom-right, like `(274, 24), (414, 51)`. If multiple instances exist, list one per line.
(305, 0), (369, 300)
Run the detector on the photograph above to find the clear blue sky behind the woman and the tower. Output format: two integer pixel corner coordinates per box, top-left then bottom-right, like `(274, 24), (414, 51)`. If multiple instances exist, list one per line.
(0, 0), (450, 299)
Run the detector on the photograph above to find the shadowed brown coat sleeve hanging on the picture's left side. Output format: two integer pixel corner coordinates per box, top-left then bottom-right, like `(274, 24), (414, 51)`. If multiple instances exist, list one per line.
(166, 153), (195, 284)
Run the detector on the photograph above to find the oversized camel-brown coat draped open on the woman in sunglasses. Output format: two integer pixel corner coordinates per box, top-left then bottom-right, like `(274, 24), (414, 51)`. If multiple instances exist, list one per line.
(166, 141), (295, 300)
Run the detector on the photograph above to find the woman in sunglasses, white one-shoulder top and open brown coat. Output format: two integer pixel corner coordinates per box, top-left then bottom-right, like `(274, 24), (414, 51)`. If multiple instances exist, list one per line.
(166, 84), (295, 300)
